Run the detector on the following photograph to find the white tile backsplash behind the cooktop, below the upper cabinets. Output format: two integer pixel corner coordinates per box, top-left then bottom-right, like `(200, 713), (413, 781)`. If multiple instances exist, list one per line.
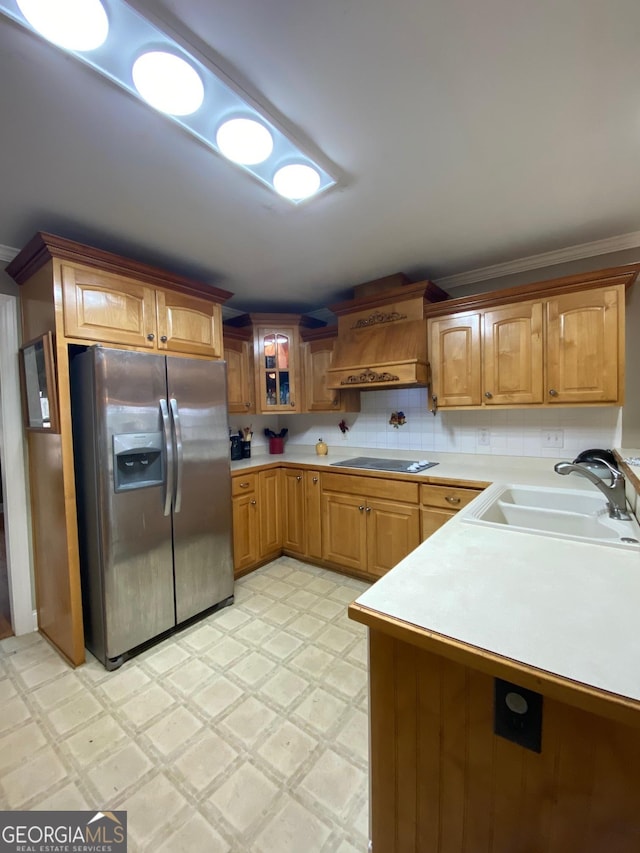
(278, 388), (622, 459)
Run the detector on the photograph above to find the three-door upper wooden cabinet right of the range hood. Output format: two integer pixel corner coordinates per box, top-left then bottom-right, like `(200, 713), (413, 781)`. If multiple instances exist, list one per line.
(427, 264), (640, 409)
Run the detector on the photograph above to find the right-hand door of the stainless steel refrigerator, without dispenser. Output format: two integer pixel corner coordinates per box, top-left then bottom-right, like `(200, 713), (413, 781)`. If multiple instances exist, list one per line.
(167, 356), (233, 623)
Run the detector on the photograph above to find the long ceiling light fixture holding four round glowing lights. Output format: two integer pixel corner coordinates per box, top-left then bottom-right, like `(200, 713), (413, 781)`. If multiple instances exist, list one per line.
(0, 0), (336, 204)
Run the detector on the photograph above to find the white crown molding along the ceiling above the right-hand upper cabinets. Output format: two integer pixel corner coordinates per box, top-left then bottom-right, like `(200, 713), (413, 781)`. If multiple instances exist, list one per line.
(434, 231), (640, 290)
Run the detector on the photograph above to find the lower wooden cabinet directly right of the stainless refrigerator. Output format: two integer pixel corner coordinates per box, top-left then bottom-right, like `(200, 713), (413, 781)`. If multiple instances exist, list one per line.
(231, 468), (282, 577)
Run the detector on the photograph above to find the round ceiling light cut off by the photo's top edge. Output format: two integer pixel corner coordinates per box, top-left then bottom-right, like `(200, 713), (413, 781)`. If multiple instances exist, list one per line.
(17, 0), (109, 52)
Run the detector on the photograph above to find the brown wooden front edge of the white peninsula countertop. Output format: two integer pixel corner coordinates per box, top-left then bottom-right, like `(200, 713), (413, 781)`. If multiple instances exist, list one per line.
(348, 601), (640, 728)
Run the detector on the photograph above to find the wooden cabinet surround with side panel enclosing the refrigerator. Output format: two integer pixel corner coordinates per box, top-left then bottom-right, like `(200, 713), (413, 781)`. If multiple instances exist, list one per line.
(7, 233), (231, 665)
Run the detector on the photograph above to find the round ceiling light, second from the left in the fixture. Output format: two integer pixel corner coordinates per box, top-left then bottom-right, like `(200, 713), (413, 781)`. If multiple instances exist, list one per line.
(132, 50), (204, 116)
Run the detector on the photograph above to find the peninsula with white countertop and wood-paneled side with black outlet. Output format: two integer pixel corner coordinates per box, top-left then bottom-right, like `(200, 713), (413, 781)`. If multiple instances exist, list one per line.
(349, 486), (640, 853)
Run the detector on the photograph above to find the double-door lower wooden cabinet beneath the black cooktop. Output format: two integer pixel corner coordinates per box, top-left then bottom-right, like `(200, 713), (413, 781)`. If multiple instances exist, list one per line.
(322, 473), (420, 578)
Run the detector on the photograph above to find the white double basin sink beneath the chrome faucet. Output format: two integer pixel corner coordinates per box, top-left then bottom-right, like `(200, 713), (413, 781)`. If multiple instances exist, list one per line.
(459, 483), (640, 550)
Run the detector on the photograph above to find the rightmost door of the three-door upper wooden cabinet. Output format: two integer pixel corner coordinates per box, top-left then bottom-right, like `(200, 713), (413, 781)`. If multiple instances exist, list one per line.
(546, 285), (624, 405)
